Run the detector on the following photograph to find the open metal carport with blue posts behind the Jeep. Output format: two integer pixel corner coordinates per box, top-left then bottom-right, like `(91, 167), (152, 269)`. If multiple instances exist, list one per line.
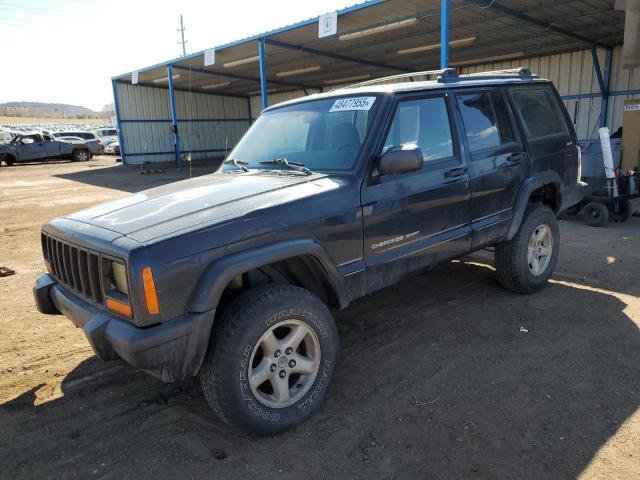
(112, 0), (640, 168)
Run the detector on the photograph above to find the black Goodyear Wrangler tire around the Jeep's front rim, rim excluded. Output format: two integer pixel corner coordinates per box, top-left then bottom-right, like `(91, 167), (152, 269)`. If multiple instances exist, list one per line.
(199, 284), (338, 435)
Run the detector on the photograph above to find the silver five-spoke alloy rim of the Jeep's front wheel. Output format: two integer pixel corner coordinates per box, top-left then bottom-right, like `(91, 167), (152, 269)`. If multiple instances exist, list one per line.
(247, 319), (320, 408)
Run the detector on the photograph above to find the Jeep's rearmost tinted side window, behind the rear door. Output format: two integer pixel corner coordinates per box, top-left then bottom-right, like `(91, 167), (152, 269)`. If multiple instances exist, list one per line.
(511, 88), (567, 140)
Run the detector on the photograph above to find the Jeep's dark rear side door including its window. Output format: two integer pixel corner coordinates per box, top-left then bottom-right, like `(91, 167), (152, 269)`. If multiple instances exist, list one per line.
(456, 87), (530, 248)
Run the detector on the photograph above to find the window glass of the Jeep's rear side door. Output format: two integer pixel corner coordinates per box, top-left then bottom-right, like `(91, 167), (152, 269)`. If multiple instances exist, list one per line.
(456, 91), (515, 152)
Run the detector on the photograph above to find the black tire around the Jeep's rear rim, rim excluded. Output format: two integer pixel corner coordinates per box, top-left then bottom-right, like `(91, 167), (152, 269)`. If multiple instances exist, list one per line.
(495, 205), (560, 293)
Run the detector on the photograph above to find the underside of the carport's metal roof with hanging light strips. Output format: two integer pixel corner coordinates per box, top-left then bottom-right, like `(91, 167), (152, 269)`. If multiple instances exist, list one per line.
(114, 0), (624, 96)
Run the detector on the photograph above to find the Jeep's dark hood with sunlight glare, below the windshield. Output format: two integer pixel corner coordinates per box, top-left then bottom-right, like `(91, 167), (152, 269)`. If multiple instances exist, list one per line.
(67, 170), (338, 243)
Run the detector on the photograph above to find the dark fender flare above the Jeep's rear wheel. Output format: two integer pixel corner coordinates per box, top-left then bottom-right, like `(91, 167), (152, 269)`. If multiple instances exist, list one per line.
(505, 170), (562, 240)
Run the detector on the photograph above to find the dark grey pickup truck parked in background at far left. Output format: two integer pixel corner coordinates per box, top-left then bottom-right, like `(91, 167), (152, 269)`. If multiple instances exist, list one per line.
(0, 132), (91, 166)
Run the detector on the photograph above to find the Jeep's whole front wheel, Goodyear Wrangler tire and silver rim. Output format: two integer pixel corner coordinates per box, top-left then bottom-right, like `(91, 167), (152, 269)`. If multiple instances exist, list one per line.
(200, 284), (338, 435)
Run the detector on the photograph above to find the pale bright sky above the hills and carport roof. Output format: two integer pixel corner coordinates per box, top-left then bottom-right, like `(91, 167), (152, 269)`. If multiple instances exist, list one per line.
(0, 0), (361, 110)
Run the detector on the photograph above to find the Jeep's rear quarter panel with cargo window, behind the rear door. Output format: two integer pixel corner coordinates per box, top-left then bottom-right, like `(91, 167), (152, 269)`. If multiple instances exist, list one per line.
(509, 84), (578, 185)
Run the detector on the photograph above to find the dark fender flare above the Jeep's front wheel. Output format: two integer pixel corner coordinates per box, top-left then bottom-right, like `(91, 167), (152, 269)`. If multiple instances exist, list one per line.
(188, 239), (348, 313)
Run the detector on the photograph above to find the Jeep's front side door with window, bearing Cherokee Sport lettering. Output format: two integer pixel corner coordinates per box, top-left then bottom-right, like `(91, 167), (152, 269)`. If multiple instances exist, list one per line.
(361, 93), (471, 291)
